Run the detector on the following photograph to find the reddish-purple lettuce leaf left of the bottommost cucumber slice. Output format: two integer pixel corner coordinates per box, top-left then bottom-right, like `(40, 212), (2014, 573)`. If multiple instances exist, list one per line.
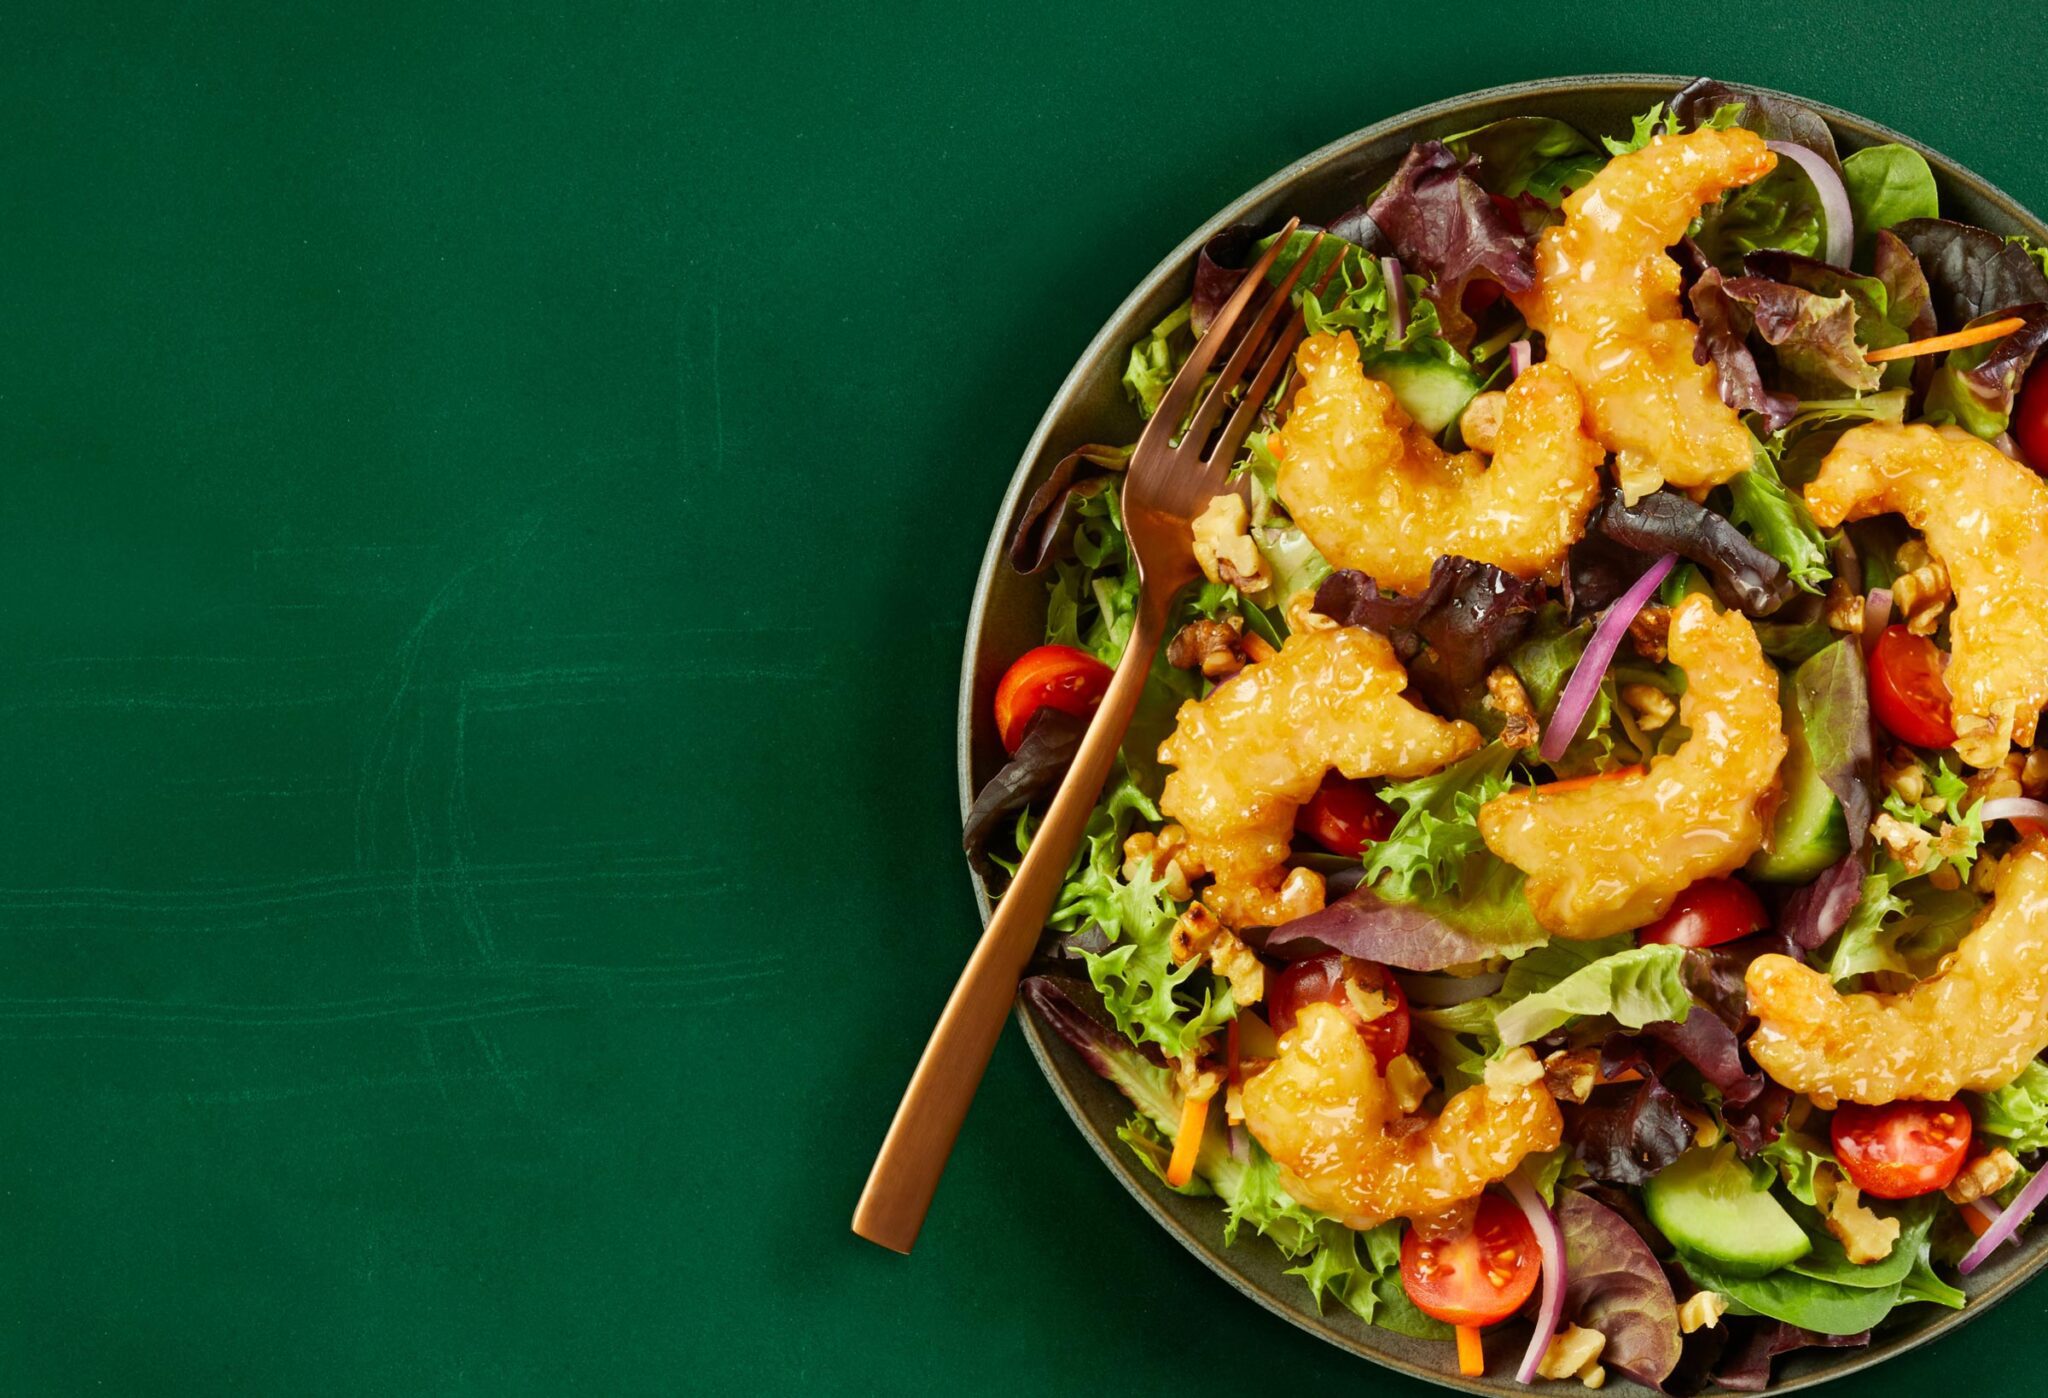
(1556, 1189), (1679, 1388)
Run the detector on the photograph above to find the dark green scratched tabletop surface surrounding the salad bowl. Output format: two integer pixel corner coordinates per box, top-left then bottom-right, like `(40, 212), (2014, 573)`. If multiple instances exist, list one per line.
(0, 0), (2048, 1394)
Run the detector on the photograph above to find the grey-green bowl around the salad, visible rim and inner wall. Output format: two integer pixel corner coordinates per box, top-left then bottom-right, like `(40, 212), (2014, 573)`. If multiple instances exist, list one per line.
(958, 74), (2048, 1396)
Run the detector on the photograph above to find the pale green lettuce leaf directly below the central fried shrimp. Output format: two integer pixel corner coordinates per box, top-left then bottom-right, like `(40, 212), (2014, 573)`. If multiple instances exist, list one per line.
(1495, 935), (1692, 1046)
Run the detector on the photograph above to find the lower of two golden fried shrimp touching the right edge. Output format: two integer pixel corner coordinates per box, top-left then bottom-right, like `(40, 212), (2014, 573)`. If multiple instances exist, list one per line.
(1745, 837), (2048, 1107)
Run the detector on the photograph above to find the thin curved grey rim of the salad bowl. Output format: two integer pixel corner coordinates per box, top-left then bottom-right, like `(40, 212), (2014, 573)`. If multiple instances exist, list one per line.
(954, 74), (2048, 1394)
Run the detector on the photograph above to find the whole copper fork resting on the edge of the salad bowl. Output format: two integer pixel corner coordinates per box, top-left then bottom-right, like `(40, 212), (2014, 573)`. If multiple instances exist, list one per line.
(854, 219), (1323, 1253)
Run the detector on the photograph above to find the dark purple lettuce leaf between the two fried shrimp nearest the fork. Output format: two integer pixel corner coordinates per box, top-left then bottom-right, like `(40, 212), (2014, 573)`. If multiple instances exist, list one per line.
(1315, 557), (1544, 714)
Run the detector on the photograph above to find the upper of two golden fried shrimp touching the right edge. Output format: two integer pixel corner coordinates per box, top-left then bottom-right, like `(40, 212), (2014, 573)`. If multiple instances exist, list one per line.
(1806, 424), (2048, 768)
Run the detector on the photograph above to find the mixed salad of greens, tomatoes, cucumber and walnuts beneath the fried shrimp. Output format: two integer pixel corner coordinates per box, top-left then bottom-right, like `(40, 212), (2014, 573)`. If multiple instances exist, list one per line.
(967, 82), (2048, 1394)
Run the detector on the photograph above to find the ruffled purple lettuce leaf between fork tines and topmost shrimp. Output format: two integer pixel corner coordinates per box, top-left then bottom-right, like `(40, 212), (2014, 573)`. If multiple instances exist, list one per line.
(1366, 141), (1536, 350)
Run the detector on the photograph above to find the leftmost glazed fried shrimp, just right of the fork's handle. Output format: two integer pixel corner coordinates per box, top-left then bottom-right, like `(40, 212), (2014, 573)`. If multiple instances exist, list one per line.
(1159, 626), (1479, 927)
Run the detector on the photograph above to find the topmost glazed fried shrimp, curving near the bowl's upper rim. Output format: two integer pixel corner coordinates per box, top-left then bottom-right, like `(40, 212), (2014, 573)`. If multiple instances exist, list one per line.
(1516, 129), (1778, 501)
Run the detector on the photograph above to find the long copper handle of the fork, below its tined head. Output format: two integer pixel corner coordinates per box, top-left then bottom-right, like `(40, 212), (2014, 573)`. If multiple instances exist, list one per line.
(854, 587), (1171, 1253)
